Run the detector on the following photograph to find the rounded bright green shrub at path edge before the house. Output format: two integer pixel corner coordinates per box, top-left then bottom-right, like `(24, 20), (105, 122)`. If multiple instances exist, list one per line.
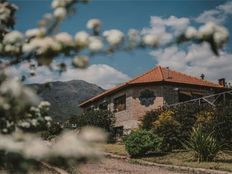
(124, 129), (162, 157)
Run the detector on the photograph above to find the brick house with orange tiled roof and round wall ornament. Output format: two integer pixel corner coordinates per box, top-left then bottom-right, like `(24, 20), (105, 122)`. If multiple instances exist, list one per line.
(80, 66), (225, 132)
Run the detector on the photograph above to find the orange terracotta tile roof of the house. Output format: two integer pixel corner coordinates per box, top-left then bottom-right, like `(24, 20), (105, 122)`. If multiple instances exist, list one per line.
(80, 66), (223, 106)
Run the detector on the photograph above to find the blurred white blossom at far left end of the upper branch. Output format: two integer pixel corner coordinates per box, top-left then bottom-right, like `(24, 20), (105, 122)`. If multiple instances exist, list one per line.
(3, 31), (24, 44)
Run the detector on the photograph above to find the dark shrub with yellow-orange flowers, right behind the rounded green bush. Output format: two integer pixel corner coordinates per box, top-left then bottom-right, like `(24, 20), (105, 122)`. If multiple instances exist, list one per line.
(141, 103), (212, 151)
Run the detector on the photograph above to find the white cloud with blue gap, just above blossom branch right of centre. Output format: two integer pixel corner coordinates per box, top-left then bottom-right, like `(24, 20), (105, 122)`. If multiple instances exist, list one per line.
(142, 16), (190, 44)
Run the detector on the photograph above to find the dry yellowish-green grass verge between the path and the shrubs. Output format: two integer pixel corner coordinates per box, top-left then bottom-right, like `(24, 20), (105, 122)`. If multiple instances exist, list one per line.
(102, 144), (232, 172)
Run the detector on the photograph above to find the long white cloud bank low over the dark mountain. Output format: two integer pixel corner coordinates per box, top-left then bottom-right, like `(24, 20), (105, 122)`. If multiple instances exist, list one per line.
(11, 63), (130, 89)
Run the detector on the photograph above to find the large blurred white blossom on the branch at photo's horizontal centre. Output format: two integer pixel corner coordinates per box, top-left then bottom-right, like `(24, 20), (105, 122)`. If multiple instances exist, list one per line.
(103, 29), (124, 46)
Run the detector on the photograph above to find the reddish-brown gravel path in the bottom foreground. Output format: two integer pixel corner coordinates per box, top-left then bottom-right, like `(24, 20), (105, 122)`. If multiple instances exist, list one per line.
(79, 158), (184, 174)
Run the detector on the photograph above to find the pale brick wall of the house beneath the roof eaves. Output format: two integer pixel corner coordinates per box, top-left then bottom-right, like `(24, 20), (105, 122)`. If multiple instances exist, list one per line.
(81, 85), (214, 130)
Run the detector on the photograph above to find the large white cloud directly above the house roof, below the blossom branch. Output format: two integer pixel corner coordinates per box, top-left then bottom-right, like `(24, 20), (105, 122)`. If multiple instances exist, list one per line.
(151, 43), (232, 82)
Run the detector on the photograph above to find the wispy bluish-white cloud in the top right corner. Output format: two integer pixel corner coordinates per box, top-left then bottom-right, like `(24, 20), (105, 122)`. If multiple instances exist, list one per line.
(195, 1), (232, 23)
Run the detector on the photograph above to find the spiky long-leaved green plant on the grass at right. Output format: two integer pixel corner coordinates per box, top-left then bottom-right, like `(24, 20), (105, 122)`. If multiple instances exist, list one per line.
(184, 127), (220, 162)
